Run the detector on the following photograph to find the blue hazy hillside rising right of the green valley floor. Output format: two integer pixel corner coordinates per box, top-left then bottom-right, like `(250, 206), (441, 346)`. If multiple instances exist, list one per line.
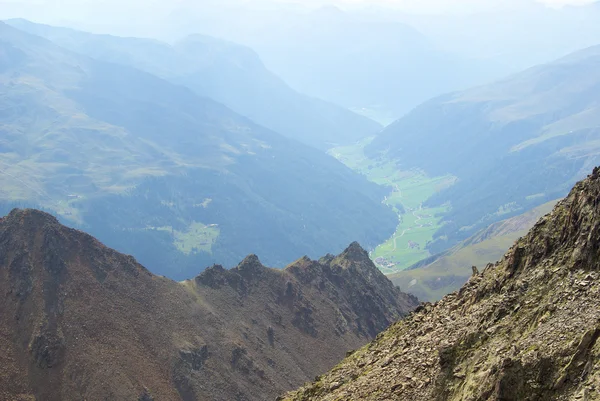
(365, 43), (600, 253)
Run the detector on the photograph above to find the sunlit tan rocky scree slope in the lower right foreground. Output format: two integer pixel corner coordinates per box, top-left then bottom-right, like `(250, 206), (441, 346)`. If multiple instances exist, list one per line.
(284, 169), (600, 401)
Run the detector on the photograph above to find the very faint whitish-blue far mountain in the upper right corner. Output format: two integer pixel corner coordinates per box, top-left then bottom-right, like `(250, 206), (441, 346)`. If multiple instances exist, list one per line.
(400, 0), (600, 74)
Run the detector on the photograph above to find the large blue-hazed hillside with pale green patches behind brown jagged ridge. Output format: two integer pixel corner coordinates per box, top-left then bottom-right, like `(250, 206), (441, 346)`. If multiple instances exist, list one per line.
(0, 23), (395, 279)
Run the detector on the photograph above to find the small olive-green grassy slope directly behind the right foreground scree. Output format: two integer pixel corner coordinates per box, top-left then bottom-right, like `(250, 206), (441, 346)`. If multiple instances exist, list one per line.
(388, 201), (556, 302)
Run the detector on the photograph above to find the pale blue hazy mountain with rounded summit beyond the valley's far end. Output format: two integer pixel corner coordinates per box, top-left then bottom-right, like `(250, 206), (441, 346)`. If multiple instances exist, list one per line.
(232, 6), (498, 118)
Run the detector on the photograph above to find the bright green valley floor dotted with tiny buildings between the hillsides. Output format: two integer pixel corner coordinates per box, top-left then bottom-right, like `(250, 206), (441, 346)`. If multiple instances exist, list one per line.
(329, 138), (455, 274)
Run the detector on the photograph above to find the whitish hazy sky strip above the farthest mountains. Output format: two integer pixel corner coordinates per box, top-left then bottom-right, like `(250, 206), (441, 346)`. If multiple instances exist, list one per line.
(0, 0), (593, 37)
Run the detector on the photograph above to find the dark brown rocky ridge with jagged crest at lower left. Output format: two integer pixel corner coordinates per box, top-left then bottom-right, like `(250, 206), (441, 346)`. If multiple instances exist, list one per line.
(0, 210), (416, 401)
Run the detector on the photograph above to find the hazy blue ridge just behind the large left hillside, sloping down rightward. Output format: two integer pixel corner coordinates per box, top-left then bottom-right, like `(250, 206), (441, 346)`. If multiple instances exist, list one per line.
(7, 20), (382, 150)
